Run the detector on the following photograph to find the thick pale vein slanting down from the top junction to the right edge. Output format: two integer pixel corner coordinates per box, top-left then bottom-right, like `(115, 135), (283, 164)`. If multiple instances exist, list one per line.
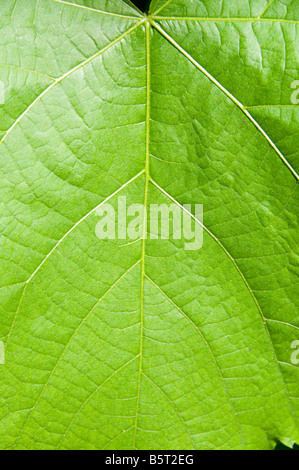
(151, 21), (299, 181)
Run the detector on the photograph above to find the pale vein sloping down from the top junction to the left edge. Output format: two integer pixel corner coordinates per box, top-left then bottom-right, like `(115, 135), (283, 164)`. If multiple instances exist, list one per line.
(0, 19), (145, 145)
